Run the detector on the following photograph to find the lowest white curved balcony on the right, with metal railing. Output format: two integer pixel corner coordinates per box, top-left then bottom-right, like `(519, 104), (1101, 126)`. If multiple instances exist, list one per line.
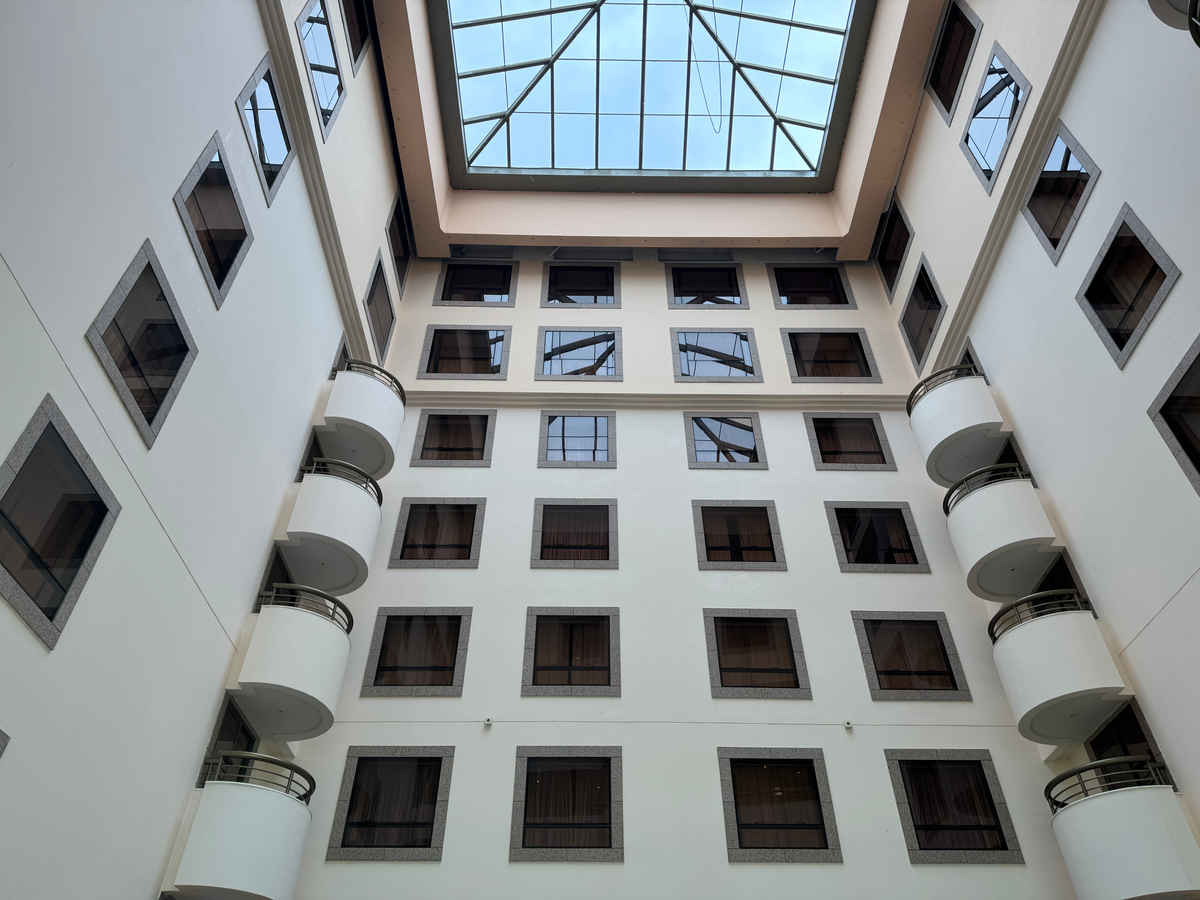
(1045, 756), (1200, 900)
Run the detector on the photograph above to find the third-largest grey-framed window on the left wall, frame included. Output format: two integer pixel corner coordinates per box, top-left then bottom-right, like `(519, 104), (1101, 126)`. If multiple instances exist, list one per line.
(175, 132), (254, 310)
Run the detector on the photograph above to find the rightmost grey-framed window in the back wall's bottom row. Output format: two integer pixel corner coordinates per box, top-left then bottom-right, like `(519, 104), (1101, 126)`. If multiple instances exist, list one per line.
(883, 750), (1025, 865)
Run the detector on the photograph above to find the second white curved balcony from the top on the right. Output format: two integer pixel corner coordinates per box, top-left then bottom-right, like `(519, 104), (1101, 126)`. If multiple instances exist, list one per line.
(942, 463), (1057, 602)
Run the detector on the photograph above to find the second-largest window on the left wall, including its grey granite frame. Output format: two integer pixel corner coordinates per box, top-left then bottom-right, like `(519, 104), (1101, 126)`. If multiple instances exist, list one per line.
(86, 240), (198, 448)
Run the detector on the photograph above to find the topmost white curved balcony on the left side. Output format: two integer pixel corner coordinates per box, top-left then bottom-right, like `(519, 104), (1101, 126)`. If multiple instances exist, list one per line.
(316, 359), (407, 478)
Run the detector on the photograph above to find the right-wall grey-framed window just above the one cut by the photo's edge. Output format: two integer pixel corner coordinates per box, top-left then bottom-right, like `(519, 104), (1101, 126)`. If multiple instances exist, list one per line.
(1075, 203), (1180, 368)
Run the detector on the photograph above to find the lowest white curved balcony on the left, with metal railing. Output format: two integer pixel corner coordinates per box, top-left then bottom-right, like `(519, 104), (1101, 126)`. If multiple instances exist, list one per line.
(174, 752), (317, 900)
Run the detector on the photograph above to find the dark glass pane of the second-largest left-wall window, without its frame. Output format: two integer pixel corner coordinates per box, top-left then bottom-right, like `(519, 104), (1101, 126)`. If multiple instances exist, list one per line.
(104, 264), (187, 422)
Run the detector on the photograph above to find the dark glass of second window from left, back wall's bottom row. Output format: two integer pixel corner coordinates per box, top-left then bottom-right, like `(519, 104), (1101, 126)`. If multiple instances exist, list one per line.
(523, 757), (612, 847)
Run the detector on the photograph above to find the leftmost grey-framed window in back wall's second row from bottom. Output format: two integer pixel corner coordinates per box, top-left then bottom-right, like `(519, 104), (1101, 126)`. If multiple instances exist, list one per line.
(359, 606), (472, 697)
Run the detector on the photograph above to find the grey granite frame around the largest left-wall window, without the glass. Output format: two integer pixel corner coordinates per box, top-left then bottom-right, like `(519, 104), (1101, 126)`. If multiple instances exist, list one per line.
(0, 394), (121, 652)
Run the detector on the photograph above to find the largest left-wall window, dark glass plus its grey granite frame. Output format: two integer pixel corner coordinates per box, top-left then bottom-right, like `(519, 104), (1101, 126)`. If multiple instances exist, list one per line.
(0, 395), (121, 649)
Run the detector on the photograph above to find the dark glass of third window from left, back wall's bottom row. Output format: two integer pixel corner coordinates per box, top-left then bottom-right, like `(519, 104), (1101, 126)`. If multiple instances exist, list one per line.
(730, 760), (829, 850)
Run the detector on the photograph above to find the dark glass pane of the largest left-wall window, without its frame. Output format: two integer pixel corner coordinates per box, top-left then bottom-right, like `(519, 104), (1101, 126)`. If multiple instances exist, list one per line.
(0, 425), (108, 619)
